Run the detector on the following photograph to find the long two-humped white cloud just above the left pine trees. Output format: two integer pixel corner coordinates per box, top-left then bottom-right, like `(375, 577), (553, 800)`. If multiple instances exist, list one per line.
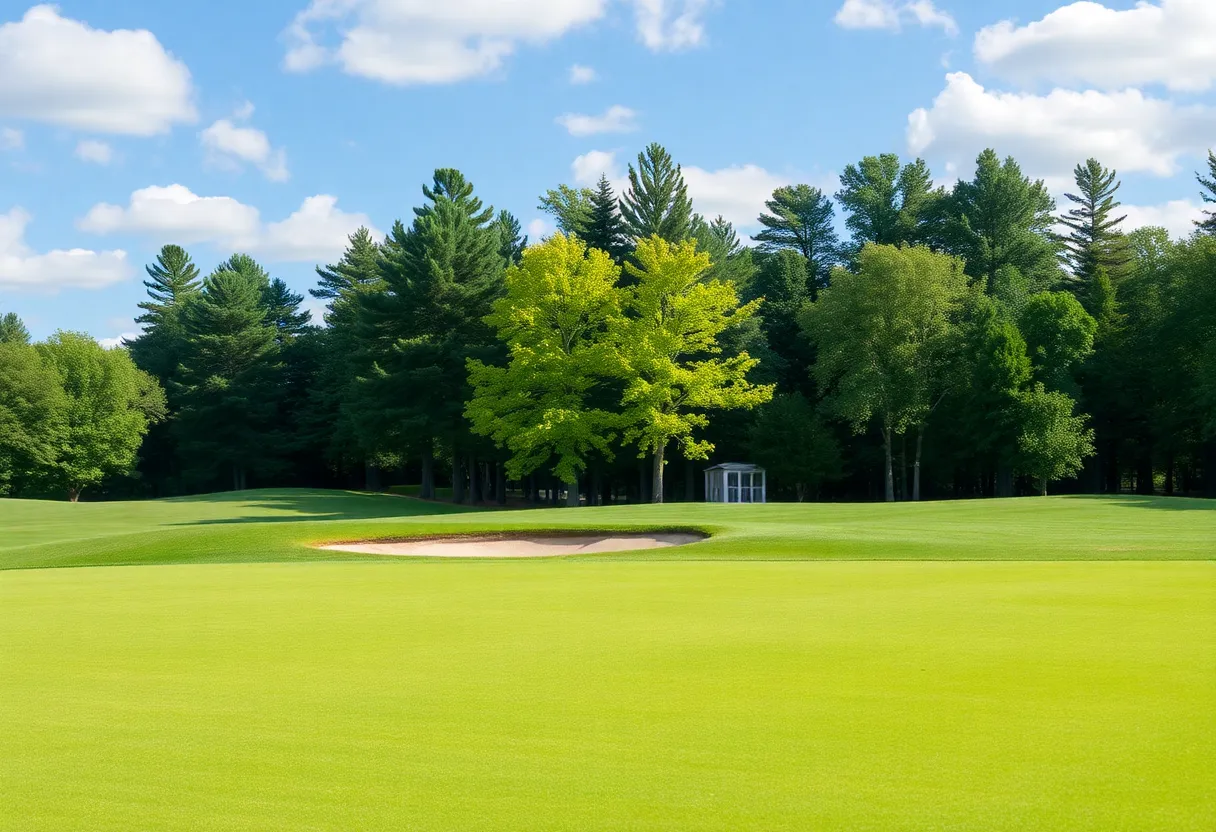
(78, 185), (383, 263)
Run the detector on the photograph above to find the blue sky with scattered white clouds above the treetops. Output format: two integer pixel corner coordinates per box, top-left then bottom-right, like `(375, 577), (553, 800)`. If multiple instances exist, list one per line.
(0, 0), (1216, 338)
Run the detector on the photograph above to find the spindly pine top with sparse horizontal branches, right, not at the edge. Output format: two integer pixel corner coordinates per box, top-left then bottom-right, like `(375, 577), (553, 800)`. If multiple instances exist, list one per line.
(1059, 158), (1131, 286)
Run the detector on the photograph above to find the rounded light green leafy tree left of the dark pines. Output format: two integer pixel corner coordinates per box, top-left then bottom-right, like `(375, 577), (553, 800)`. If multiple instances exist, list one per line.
(36, 332), (164, 501)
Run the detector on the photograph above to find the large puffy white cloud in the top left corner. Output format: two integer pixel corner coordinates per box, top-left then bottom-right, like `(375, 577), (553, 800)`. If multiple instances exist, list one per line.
(0, 5), (196, 136)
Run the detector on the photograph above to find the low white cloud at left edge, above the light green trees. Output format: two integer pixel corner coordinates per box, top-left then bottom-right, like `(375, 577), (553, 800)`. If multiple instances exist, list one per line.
(0, 208), (130, 292)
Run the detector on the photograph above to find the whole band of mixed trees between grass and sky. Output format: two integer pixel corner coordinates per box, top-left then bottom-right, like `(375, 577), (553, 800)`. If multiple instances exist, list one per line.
(0, 144), (1216, 505)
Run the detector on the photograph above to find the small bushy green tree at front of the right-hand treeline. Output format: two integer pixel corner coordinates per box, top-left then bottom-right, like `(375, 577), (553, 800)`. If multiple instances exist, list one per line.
(1018, 382), (1093, 496)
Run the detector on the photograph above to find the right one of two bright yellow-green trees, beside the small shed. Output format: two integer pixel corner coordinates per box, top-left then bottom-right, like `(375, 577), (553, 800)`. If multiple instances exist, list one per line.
(614, 236), (772, 502)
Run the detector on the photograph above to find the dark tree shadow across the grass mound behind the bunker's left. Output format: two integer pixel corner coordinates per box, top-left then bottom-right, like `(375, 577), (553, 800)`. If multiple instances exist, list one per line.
(171, 489), (472, 525)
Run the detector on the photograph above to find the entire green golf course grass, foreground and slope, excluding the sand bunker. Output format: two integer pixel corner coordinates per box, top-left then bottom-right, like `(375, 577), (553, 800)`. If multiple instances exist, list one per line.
(0, 491), (1216, 832)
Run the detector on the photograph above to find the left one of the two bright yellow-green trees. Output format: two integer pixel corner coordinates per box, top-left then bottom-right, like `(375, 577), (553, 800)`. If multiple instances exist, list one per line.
(466, 234), (621, 484)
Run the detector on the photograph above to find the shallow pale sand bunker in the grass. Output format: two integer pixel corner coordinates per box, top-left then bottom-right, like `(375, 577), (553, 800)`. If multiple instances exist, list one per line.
(321, 532), (704, 557)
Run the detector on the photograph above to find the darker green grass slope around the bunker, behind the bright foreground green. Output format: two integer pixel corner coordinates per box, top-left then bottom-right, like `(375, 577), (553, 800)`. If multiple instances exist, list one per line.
(0, 489), (1216, 569)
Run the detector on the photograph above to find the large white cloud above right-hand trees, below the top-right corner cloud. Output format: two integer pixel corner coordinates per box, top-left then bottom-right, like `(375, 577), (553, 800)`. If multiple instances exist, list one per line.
(907, 72), (1216, 179)
